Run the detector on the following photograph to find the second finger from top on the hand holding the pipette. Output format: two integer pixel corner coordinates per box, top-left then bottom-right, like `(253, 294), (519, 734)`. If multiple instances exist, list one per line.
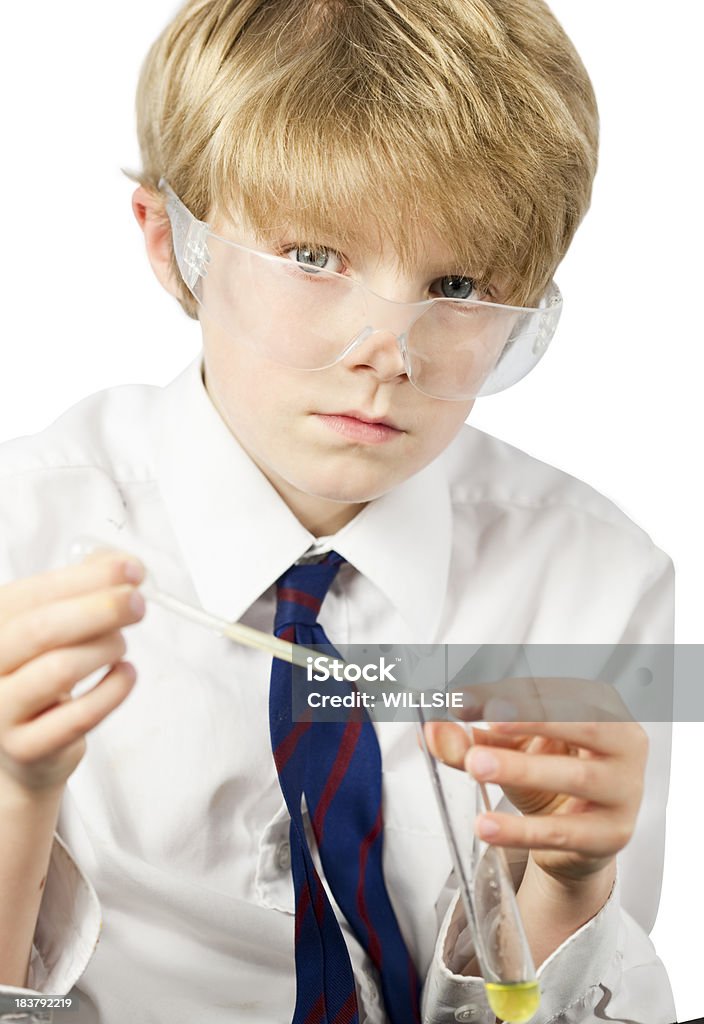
(0, 584), (144, 686)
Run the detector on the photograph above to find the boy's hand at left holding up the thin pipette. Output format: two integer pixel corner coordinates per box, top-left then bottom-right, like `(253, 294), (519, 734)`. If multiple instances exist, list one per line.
(0, 550), (144, 795)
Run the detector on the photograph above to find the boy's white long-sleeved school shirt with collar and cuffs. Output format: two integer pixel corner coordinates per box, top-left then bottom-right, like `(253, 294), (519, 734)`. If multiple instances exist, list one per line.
(0, 356), (675, 1024)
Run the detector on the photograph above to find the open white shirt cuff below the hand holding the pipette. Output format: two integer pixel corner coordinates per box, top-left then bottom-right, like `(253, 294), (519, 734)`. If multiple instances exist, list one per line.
(0, 834), (101, 999)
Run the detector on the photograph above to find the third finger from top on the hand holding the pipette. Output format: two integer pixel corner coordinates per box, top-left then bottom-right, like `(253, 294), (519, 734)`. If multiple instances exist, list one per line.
(3, 632), (127, 725)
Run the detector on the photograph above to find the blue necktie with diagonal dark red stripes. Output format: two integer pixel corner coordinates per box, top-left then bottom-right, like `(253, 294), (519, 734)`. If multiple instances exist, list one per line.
(269, 551), (420, 1024)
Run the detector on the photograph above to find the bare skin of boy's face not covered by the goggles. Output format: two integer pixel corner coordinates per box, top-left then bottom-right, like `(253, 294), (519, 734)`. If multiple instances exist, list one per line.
(201, 212), (474, 536)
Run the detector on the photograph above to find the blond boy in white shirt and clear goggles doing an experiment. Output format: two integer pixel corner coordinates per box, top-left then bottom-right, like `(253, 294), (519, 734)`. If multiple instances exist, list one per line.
(0, 0), (673, 1024)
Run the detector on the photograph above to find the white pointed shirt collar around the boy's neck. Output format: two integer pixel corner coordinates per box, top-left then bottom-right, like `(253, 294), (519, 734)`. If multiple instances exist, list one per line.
(157, 353), (451, 643)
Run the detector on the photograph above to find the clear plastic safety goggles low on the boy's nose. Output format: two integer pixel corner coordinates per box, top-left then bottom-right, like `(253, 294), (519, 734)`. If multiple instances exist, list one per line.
(160, 179), (562, 400)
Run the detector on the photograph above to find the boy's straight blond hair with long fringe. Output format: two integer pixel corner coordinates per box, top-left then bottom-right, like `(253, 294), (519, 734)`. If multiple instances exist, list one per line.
(133, 0), (598, 315)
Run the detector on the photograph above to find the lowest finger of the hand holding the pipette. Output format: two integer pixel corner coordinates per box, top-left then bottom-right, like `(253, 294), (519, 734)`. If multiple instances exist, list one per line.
(3, 662), (137, 764)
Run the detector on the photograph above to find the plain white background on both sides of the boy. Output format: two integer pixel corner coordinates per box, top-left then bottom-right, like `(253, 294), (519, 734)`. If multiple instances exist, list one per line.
(0, 0), (704, 1020)
